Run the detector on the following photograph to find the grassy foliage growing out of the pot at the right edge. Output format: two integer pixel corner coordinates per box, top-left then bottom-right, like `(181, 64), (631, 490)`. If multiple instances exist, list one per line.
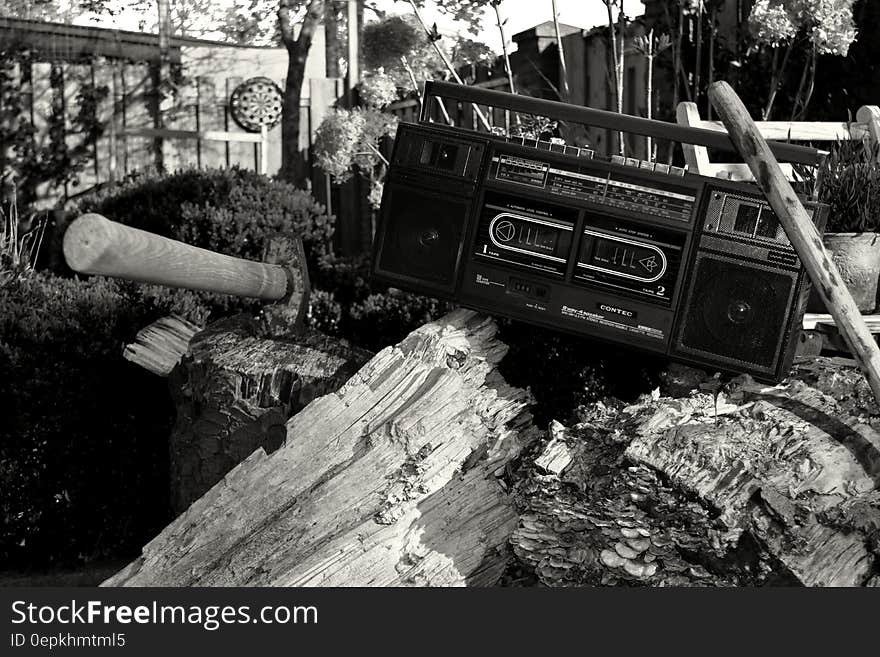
(820, 141), (880, 233)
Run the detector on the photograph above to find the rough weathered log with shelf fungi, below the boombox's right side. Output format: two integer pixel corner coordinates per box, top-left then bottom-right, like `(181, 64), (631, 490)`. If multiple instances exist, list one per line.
(511, 359), (880, 586)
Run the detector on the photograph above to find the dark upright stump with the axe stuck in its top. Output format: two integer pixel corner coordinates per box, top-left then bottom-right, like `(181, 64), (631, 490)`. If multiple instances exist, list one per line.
(169, 315), (372, 513)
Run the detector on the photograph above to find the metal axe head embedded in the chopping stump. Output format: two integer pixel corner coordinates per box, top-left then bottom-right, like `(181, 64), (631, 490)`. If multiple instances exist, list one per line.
(260, 235), (311, 336)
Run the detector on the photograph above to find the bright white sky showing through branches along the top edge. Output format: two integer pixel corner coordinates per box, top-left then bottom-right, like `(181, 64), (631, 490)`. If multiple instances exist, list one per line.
(62, 0), (643, 53)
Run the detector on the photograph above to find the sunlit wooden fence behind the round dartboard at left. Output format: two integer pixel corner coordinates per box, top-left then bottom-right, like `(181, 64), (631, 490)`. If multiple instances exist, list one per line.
(0, 18), (342, 207)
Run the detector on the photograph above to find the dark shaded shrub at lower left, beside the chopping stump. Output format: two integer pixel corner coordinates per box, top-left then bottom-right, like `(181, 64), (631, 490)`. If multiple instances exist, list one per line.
(0, 274), (189, 567)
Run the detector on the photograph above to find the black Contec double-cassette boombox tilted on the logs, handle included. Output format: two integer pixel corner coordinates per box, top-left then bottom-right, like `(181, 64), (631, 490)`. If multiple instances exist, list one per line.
(372, 82), (827, 381)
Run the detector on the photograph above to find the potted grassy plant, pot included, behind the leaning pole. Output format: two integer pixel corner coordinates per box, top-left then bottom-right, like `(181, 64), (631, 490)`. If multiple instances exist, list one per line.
(808, 141), (880, 312)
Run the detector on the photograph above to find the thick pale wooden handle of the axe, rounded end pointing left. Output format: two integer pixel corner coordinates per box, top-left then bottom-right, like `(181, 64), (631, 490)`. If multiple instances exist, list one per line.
(64, 214), (289, 301)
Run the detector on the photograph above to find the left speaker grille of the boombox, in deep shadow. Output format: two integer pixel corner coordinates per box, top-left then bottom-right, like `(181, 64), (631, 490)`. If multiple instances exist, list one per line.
(378, 185), (470, 292)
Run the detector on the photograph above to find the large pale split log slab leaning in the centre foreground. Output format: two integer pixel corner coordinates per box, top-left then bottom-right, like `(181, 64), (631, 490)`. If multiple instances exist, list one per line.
(105, 310), (534, 586)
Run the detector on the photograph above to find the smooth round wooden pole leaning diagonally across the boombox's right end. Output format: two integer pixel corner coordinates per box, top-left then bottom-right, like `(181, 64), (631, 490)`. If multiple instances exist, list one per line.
(709, 81), (880, 403)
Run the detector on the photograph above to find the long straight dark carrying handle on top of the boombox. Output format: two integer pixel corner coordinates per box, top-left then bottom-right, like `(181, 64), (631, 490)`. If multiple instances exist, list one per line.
(419, 80), (825, 166)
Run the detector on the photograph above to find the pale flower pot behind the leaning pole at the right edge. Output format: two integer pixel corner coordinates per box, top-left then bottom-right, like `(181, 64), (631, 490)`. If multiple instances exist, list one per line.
(807, 233), (880, 313)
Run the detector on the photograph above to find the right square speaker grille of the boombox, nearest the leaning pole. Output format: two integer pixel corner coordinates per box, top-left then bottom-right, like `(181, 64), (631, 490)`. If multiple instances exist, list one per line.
(674, 253), (797, 375)
